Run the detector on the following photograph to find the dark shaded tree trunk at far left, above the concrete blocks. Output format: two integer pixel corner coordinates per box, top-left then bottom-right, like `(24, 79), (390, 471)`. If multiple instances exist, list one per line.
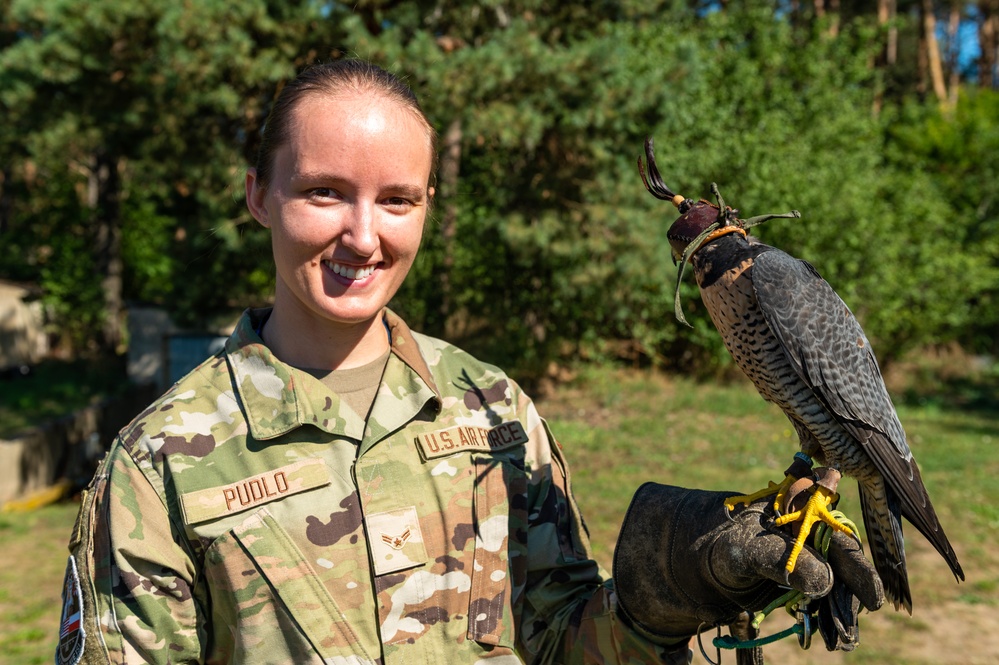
(87, 150), (124, 355)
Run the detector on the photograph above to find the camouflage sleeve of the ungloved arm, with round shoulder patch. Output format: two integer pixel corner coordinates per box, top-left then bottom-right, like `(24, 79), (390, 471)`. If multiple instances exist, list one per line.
(56, 443), (205, 664)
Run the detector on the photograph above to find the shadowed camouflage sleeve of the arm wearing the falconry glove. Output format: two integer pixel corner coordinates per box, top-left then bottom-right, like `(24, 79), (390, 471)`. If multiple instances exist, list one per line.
(520, 424), (687, 665)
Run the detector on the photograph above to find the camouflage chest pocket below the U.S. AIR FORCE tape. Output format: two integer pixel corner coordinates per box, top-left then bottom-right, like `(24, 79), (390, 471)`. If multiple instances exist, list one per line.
(468, 456), (527, 648)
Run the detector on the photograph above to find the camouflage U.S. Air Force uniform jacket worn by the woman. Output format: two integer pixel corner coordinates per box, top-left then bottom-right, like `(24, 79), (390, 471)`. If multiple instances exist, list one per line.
(57, 310), (672, 665)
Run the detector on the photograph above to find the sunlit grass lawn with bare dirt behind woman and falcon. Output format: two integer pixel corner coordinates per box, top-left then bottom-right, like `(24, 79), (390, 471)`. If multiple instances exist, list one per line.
(0, 368), (999, 665)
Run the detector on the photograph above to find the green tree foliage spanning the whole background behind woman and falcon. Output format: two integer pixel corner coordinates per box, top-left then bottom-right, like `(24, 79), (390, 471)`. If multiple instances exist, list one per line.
(0, 0), (999, 377)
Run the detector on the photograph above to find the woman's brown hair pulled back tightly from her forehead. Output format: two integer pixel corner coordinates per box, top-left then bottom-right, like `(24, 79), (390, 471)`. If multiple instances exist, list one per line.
(256, 59), (437, 188)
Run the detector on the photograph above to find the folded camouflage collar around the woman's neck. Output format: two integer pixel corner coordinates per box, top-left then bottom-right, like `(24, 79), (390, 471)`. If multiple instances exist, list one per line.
(225, 308), (441, 445)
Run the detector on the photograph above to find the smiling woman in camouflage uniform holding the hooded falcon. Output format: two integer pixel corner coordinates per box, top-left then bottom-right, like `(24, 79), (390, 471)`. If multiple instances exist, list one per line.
(56, 61), (884, 665)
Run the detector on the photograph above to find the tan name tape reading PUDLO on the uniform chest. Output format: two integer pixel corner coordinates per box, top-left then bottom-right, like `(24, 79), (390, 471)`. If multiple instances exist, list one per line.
(180, 458), (330, 524)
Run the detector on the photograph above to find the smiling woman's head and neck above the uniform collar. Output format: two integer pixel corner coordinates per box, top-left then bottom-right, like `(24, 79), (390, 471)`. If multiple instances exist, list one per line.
(246, 64), (435, 370)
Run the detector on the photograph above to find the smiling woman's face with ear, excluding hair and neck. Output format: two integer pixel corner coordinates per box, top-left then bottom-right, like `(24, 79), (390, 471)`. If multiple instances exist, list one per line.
(246, 92), (433, 332)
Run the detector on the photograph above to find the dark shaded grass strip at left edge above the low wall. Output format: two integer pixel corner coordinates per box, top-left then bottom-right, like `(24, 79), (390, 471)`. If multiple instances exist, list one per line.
(0, 360), (127, 437)
